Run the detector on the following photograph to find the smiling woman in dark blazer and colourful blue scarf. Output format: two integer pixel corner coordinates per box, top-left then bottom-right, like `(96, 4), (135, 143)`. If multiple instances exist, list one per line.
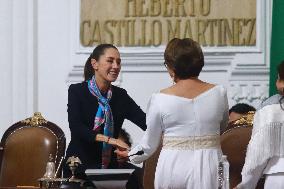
(63, 44), (146, 185)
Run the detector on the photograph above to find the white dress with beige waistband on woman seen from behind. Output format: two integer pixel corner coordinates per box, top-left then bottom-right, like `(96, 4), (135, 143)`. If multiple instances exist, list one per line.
(129, 85), (228, 189)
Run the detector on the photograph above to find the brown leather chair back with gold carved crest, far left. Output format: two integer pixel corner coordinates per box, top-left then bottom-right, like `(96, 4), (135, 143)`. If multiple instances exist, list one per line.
(0, 112), (66, 187)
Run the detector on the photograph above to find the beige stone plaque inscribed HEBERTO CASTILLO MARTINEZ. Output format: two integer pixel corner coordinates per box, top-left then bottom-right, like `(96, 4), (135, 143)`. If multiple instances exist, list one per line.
(80, 0), (256, 47)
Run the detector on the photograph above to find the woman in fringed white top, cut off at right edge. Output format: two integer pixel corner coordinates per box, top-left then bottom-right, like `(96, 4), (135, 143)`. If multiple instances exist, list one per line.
(236, 61), (284, 189)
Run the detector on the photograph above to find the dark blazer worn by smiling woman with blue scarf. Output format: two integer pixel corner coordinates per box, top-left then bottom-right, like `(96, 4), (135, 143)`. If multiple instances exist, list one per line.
(65, 82), (146, 175)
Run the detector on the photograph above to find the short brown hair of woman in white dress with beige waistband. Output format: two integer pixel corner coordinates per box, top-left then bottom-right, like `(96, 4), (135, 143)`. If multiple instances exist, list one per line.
(164, 38), (204, 79)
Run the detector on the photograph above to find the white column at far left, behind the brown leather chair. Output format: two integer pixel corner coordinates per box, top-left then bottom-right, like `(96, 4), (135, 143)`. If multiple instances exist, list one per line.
(0, 0), (34, 139)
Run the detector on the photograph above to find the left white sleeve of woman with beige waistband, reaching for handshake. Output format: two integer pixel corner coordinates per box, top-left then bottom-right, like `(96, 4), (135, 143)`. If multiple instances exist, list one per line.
(128, 94), (163, 163)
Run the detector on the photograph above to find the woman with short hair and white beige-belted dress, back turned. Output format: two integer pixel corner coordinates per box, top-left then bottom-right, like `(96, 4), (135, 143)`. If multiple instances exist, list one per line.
(117, 38), (228, 189)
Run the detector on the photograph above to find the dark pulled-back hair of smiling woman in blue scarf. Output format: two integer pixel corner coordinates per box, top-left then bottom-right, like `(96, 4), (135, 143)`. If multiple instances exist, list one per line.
(84, 43), (118, 81)
